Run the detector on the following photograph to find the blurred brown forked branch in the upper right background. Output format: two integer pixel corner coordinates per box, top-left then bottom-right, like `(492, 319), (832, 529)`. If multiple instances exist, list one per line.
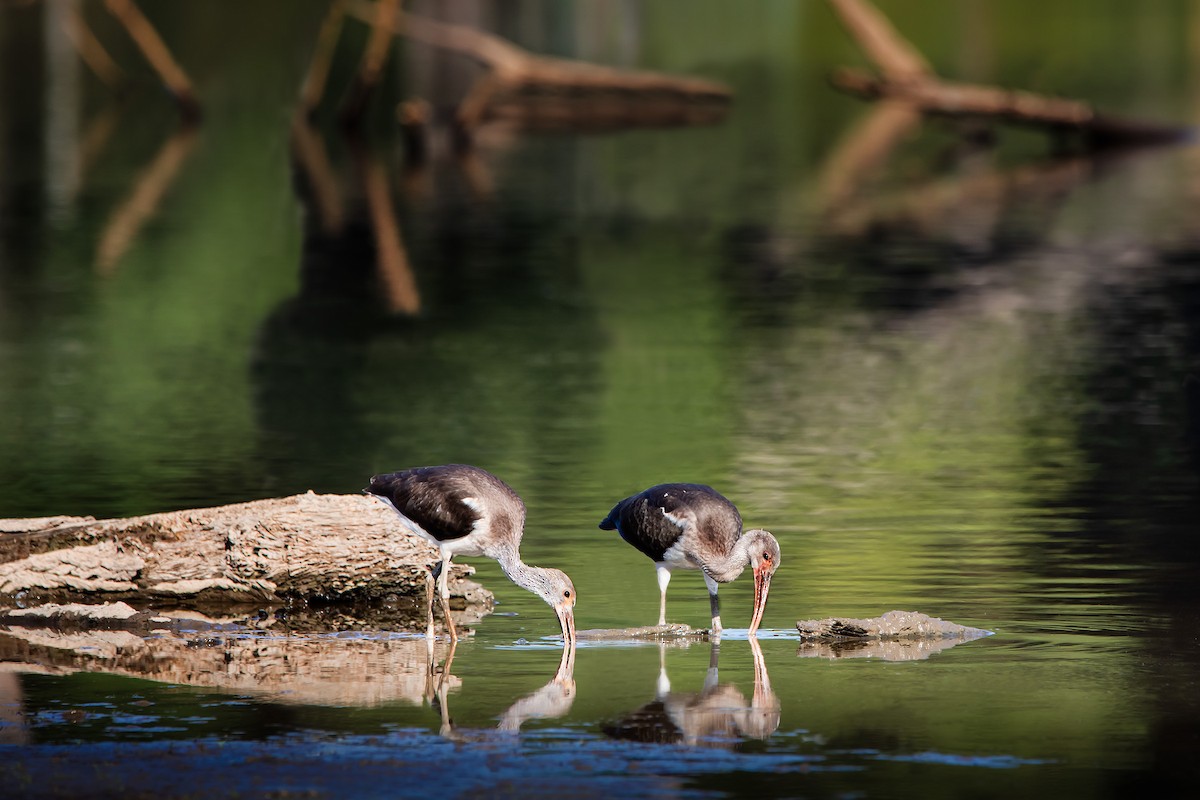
(829, 0), (1190, 146)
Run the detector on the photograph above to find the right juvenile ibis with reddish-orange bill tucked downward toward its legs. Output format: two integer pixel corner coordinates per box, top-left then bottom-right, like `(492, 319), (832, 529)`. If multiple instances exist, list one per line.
(600, 483), (779, 636)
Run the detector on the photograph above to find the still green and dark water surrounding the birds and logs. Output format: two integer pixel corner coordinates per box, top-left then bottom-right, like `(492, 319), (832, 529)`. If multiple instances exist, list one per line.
(0, 0), (1200, 798)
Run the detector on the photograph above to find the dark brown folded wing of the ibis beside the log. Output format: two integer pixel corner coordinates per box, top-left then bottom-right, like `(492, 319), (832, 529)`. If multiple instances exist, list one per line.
(367, 467), (482, 541)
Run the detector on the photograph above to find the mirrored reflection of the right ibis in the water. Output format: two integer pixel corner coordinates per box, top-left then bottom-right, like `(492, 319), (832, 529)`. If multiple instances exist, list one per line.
(604, 637), (780, 746)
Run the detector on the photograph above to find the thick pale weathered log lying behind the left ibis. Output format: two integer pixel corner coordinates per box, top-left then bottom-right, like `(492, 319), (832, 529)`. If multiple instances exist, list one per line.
(0, 492), (493, 609)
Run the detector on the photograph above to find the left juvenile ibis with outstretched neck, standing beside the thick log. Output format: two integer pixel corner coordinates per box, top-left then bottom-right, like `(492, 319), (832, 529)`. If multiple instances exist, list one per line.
(364, 464), (576, 648)
